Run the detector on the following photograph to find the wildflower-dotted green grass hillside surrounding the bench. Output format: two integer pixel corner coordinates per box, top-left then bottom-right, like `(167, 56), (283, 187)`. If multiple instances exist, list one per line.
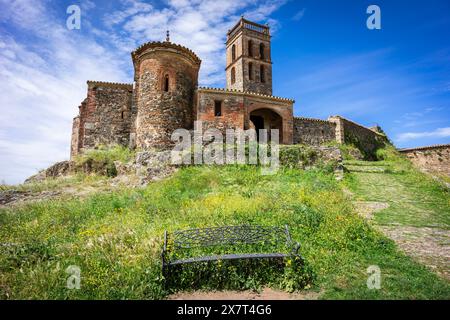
(0, 162), (450, 299)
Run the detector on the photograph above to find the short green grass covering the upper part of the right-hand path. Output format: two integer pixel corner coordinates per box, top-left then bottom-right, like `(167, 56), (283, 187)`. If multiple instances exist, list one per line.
(345, 149), (450, 229)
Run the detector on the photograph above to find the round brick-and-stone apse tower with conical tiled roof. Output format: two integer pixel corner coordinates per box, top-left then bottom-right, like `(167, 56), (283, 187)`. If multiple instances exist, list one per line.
(131, 37), (201, 149)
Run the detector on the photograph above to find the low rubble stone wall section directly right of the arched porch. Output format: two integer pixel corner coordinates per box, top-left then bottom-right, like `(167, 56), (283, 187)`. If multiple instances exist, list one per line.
(294, 117), (336, 145)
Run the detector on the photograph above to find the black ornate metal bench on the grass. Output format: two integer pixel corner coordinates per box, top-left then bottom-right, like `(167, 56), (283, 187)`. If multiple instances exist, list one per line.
(161, 225), (300, 275)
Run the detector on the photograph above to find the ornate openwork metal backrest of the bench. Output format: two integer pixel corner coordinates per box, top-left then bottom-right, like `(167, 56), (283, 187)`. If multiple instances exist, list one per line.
(173, 225), (291, 249)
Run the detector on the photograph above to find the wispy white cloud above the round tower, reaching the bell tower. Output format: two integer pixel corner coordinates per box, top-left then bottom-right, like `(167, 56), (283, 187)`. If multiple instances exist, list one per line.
(113, 0), (286, 85)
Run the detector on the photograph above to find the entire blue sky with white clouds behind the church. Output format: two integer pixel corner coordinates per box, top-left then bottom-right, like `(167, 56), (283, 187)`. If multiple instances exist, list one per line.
(0, 0), (450, 183)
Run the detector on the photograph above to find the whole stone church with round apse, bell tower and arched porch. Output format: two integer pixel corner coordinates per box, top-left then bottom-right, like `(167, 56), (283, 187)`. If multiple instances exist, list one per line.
(71, 17), (381, 157)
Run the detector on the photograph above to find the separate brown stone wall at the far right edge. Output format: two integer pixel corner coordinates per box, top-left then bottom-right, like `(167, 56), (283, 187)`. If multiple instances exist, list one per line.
(399, 144), (450, 176)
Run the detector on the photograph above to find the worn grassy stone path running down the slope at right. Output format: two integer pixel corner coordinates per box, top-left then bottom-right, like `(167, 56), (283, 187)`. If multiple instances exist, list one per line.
(351, 162), (450, 281)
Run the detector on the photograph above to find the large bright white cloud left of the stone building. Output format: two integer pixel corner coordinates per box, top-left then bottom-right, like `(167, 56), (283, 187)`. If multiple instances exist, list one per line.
(0, 1), (128, 183)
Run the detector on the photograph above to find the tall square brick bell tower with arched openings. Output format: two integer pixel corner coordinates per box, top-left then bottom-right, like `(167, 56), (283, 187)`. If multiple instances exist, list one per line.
(226, 17), (272, 95)
